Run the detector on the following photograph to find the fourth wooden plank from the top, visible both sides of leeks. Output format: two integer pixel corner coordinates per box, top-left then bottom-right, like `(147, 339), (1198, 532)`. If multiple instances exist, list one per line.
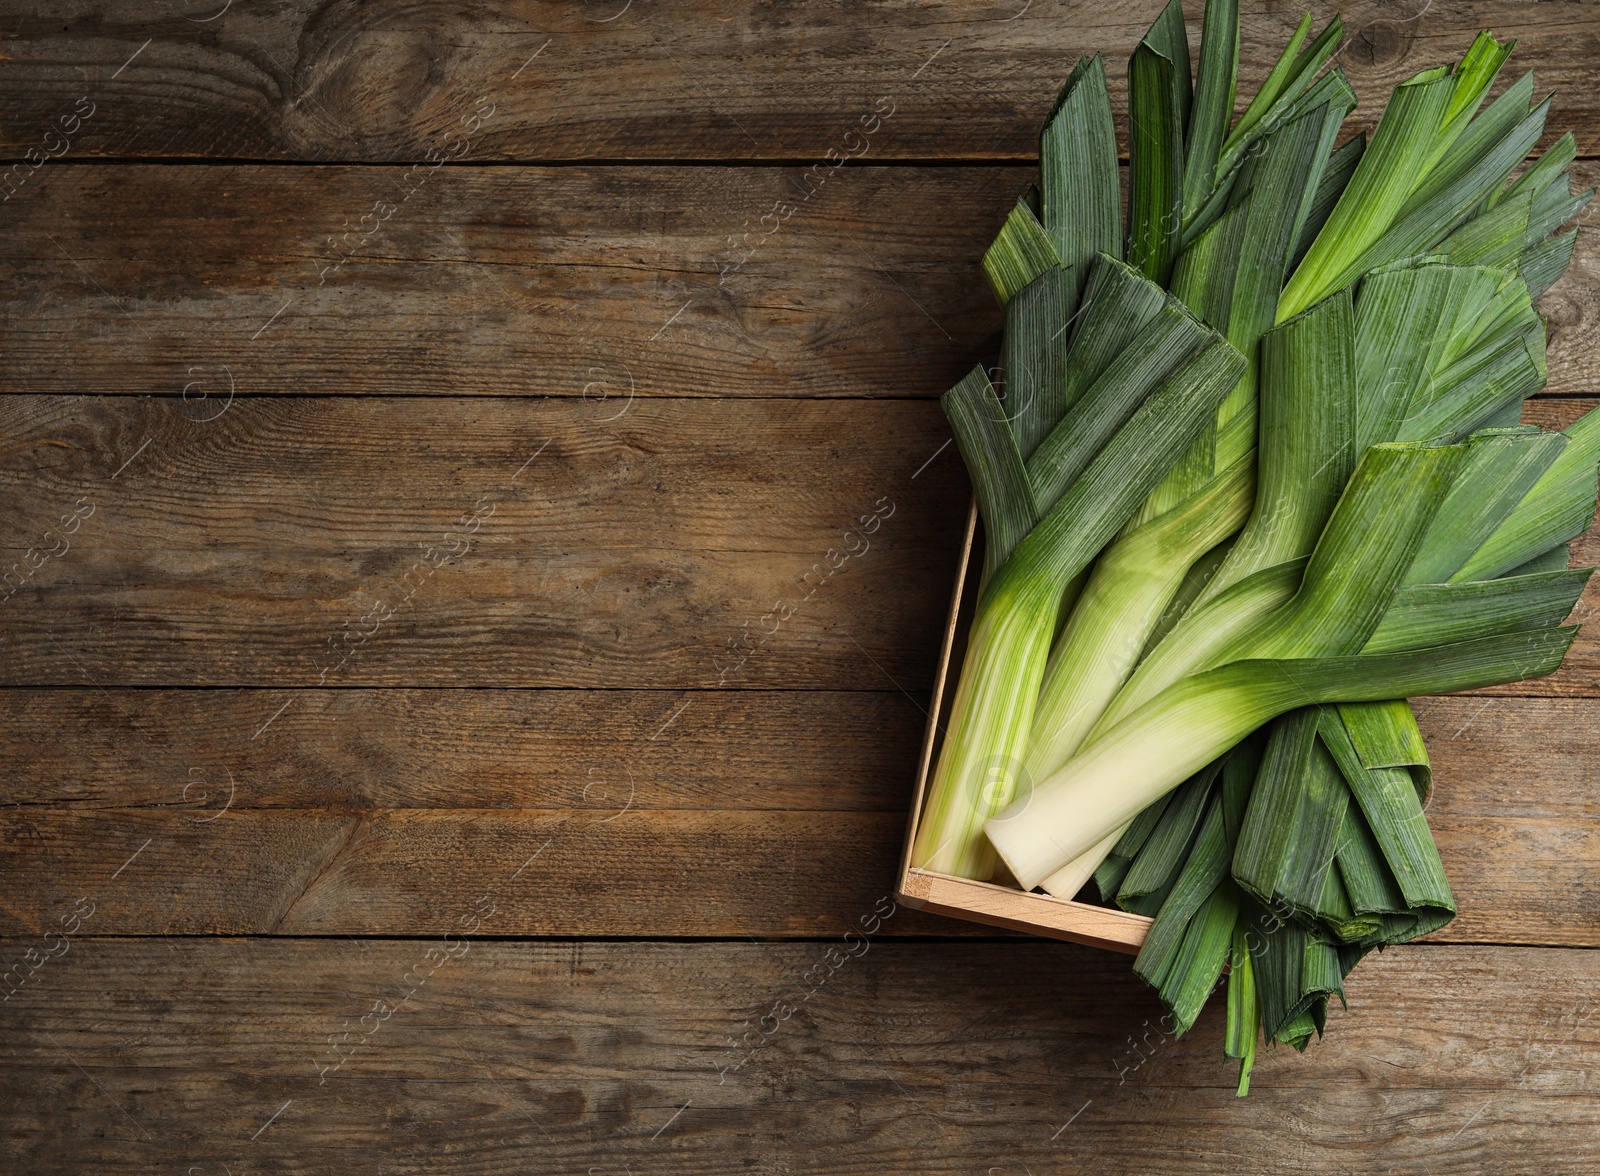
(0, 690), (1600, 946)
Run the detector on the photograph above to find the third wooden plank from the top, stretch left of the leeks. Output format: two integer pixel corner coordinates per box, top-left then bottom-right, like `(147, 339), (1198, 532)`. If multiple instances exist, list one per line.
(0, 397), (970, 691)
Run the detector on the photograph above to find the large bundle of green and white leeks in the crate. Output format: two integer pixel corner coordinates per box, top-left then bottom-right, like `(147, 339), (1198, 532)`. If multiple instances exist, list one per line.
(912, 0), (1600, 1094)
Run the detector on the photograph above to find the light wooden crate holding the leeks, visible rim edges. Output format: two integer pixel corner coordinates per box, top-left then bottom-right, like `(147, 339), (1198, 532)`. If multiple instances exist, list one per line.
(894, 502), (1150, 954)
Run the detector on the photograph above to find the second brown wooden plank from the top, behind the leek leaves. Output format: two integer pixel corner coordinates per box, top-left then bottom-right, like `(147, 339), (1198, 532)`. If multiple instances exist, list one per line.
(0, 163), (1600, 403)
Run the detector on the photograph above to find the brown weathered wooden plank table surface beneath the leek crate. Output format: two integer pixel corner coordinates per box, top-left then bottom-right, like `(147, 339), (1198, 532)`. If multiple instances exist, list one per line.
(0, 0), (1600, 1176)
